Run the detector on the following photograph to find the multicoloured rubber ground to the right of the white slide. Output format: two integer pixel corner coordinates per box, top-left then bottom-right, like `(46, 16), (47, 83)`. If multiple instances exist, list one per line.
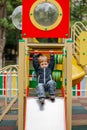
(72, 98), (87, 128)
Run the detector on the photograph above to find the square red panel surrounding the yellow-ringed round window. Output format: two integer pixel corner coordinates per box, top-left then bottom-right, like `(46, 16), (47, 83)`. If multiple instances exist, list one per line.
(22, 0), (70, 38)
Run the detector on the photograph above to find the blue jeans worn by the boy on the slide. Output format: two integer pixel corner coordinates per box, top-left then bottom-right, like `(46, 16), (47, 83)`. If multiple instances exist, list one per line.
(36, 80), (56, 98)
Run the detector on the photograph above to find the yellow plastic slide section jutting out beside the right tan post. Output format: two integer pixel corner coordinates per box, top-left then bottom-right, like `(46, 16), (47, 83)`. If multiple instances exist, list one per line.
(72, 56), (85, 85)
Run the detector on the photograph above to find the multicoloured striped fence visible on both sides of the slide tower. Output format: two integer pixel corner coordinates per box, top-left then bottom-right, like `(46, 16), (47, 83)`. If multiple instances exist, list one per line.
(0, 65), (87, 98)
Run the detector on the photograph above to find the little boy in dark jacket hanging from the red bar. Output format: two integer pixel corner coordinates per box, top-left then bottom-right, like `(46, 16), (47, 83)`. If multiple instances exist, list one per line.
(33, 51), (56, 104)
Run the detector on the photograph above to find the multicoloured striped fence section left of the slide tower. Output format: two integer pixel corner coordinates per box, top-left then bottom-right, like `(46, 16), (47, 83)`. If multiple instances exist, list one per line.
(0, 65), (18, 97)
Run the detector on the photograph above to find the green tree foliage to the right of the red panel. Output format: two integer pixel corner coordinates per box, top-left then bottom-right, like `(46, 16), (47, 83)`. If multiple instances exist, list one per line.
(70, 0), (87, 25)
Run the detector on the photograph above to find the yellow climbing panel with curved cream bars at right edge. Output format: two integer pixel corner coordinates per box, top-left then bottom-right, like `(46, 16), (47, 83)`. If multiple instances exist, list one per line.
(71, 22), (87, 66)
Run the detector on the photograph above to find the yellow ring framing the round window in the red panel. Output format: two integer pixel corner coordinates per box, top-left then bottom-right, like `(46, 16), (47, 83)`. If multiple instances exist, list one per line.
(29, 0), (63, 31)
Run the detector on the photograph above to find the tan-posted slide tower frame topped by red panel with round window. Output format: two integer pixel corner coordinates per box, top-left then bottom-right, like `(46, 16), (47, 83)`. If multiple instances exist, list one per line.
(12, 0), (72, 130)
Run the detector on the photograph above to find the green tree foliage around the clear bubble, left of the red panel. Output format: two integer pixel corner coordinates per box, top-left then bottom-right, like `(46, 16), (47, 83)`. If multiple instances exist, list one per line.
(2, 0), (22, 49)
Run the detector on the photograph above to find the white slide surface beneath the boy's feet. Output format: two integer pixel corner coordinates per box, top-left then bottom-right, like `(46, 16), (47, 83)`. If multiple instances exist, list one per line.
(25, 97), (66, 130)
